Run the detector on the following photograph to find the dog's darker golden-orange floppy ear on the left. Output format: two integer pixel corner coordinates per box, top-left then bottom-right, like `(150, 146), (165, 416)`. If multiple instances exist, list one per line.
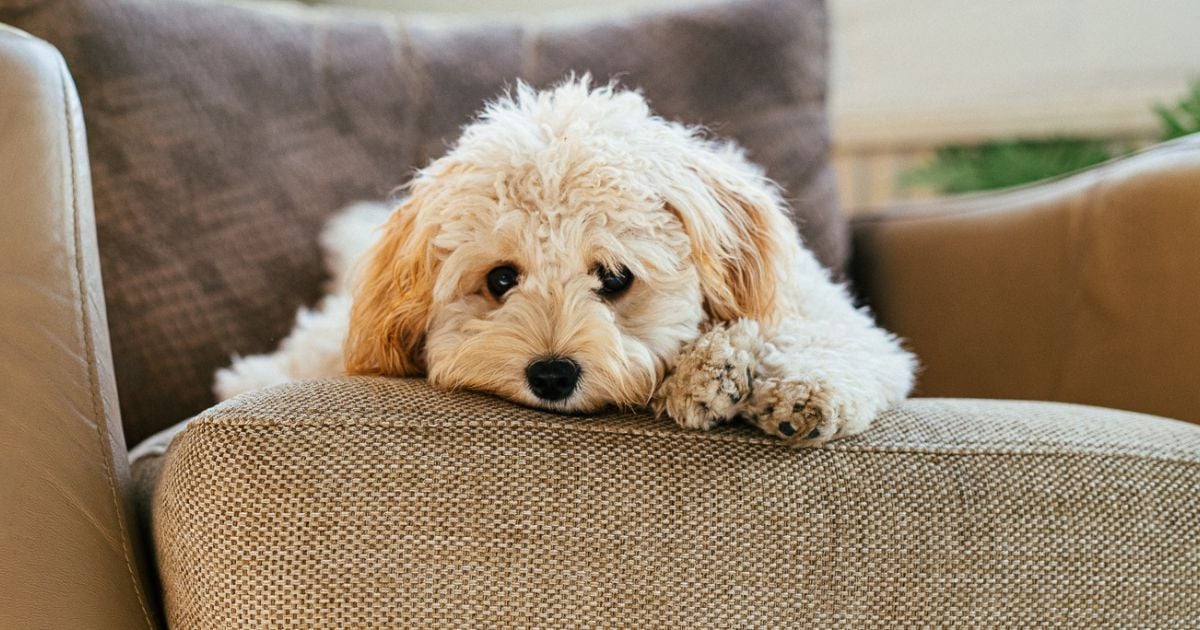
(344, 190), (437, 377)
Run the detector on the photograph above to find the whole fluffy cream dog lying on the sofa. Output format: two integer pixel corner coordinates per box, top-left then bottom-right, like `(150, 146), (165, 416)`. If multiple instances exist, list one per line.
(215, 77), (917, 445)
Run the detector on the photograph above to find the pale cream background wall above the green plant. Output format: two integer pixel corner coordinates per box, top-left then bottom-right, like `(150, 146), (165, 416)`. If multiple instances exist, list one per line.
(829, 0), (1200, 208)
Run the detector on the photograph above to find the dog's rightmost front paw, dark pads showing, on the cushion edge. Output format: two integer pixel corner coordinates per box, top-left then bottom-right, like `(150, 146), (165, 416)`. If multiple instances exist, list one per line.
(743, 378), (846, 446)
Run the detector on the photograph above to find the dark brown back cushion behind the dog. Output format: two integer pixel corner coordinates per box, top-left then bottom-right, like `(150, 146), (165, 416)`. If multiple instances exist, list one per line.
(0, 0), (847, 444)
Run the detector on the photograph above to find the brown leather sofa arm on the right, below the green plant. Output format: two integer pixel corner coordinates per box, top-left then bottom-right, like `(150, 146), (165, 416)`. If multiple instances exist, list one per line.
(852, 137), (1200, 422)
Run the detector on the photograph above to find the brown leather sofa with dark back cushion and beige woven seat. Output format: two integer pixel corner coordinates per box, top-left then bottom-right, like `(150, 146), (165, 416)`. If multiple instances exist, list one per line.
(0, 0), (1200, 628)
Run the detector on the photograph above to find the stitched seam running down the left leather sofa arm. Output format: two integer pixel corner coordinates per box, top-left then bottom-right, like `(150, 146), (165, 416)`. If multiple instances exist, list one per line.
(58, 56), (155, 630)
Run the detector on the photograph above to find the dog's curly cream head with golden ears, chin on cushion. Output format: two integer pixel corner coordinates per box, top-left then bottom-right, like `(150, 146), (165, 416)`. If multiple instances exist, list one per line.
(346, 79), (797, 412)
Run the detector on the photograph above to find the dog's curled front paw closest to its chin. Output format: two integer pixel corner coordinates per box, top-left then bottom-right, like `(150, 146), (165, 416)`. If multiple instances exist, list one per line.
(652, 320), (761, 430)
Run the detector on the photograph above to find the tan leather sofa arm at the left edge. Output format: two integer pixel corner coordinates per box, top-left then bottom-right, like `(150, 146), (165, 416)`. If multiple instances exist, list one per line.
(0, 24), (154, 628)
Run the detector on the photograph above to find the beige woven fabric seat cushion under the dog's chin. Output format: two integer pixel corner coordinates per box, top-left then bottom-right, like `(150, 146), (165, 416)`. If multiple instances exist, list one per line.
(147, 378), (1200, 628)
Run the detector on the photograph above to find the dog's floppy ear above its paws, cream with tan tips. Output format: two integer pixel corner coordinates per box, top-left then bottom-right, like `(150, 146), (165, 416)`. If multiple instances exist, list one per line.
(665, 143), (797, 322)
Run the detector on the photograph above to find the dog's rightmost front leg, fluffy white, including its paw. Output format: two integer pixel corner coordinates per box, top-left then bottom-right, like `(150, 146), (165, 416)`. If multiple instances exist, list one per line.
(742, 304), (916, 445)
